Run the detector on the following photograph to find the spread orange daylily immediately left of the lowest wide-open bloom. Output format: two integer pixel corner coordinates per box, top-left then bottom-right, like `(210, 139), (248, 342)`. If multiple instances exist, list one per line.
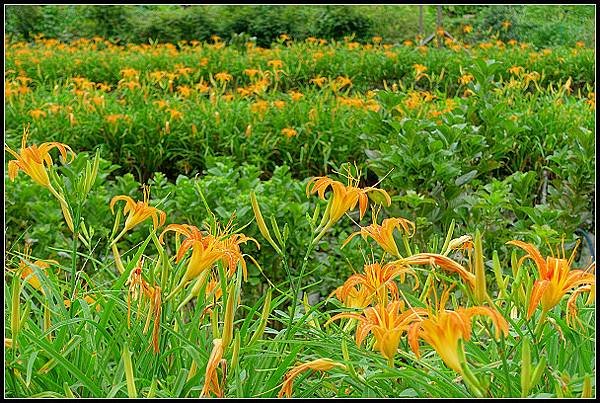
(328, 301), (427, 363)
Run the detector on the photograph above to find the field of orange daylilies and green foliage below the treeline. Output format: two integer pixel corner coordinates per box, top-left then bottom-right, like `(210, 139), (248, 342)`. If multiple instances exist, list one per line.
(4, 28), (596, 398)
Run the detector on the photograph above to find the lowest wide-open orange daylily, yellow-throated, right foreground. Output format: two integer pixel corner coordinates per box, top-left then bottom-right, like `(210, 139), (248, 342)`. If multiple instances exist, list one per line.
(408, 288), (508, 374)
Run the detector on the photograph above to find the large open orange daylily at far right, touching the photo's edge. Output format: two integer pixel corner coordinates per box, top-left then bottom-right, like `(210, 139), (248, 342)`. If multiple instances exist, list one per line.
(507, 240), (596, 319)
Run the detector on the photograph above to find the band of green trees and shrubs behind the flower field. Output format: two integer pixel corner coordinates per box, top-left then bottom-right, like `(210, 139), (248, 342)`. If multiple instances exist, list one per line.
(5, 5), (595, 47)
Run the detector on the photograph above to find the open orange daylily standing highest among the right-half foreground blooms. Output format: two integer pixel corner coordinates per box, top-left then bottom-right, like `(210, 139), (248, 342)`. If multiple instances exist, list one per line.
(306, 175), (392, 234)
